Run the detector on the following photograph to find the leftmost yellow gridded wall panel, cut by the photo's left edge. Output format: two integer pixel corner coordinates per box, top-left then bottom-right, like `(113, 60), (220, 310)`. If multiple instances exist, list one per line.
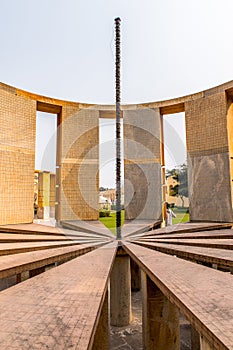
(0, 85), (36, 225)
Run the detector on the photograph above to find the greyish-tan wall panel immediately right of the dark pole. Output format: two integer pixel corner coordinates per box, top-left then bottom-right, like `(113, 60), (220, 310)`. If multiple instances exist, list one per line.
(124, 108), (162, 220)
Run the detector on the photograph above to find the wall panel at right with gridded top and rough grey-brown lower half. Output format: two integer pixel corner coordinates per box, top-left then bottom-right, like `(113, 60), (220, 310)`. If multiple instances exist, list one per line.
(185, 91), (233, 222)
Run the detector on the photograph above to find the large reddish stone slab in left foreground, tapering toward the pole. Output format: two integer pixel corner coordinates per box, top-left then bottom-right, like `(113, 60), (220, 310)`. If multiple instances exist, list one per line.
(0, 242), (116, 350)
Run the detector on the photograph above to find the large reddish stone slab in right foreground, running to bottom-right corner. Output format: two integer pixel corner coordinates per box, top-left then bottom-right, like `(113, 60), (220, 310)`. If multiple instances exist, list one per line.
(124, 244), (233, 349)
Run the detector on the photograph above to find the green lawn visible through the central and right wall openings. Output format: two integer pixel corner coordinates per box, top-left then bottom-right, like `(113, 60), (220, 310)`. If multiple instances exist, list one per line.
(99, 208), (189, 235)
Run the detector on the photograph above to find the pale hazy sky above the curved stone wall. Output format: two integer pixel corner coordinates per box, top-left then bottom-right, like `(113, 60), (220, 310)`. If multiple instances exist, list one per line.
(0, 0), (233, 186)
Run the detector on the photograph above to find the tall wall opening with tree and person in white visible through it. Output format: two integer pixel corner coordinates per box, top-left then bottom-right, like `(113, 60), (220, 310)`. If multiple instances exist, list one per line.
(162, 113), (189, 224)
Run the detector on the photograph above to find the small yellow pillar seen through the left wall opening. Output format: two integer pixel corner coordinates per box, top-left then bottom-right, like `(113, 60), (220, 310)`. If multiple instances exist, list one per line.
(37, 171), (50, 219)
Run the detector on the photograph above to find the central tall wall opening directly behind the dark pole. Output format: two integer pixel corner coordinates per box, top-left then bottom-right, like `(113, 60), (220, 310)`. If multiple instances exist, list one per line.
(99, 118), (124, 233)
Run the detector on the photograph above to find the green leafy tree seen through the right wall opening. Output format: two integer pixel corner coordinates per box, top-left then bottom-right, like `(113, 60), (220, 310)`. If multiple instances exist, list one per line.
(166, 163), (188, 207)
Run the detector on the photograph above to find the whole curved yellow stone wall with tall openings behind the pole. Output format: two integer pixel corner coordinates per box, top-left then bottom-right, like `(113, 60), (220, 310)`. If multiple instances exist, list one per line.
(0, 81), (233, 224)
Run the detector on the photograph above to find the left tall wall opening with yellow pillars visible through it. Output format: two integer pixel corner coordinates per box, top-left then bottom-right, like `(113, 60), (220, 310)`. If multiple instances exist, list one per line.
(34, 112), (58, 222)
